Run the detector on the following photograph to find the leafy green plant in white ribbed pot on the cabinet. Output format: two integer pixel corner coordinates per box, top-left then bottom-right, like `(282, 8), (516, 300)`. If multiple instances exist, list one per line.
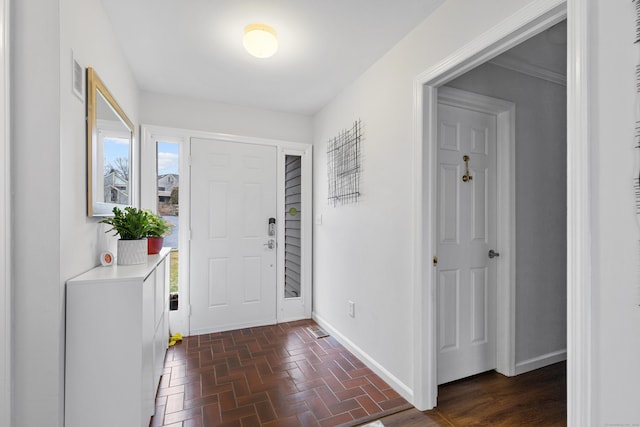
(100, 206), (151, 265)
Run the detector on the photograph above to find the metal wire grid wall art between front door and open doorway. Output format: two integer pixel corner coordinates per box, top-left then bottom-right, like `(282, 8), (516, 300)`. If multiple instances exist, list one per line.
(327, 119), (362, 206)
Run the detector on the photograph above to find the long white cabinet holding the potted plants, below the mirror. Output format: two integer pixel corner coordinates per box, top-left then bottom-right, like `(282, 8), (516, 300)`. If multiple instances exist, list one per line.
(65, 248), (170, 427)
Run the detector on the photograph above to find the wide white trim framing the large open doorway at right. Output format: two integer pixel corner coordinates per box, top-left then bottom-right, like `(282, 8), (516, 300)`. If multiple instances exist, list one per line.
(413, 1), (590, 414)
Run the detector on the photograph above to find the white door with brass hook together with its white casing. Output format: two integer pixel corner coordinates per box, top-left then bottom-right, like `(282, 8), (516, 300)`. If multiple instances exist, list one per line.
(434, 87), (515, 384)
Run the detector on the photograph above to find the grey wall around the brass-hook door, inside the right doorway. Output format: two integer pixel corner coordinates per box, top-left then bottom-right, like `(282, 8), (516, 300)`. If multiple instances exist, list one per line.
(447, 62), (567, 368)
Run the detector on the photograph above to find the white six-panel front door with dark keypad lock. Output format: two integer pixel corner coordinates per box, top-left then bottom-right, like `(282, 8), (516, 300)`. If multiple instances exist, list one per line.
(190, 138), (277, 335)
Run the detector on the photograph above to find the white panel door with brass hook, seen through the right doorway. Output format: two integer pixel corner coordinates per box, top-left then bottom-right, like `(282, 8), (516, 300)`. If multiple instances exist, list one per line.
(436, 103), (499, 384)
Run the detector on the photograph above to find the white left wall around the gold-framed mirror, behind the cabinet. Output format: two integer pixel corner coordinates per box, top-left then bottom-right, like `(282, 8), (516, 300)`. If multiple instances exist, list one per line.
(11, 0), (138, 427)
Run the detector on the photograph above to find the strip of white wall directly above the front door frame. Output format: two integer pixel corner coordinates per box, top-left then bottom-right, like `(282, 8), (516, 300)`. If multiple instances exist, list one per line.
(140, 92), (312, 143)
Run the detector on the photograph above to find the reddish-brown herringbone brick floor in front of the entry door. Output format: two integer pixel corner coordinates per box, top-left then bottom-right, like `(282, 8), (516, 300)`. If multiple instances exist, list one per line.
(151, 320), (411, 427)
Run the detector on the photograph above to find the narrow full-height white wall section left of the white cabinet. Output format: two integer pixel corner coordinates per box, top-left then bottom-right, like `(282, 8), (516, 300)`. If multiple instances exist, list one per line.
(11, 0), (64, 426)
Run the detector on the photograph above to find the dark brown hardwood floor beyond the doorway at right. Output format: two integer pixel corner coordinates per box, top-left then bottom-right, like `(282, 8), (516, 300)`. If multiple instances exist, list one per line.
(362, 362), (567, 427)
